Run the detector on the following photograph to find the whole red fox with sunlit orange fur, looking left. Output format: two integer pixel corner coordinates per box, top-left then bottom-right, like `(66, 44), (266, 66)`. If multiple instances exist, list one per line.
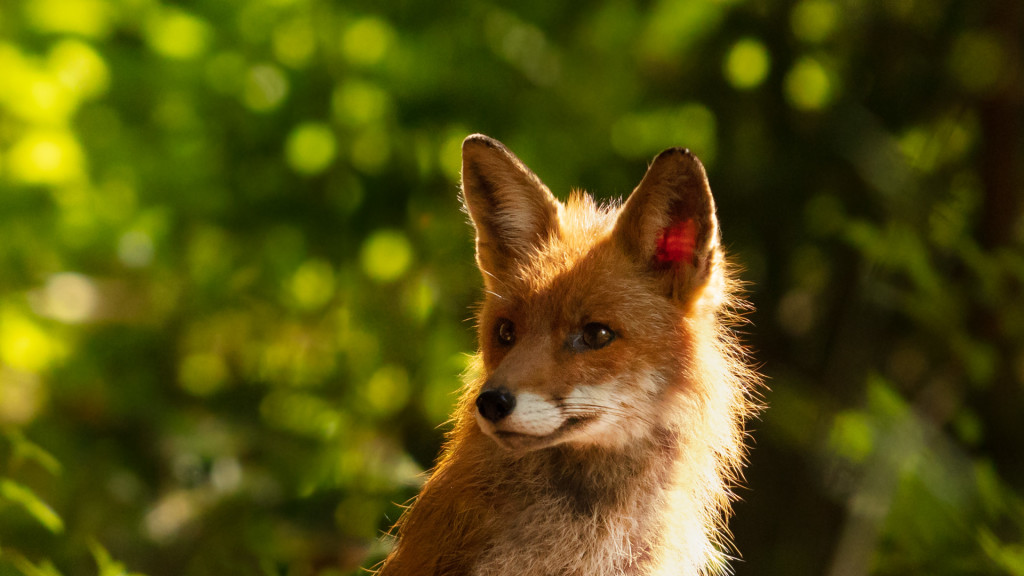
(379, 134), (759, 576)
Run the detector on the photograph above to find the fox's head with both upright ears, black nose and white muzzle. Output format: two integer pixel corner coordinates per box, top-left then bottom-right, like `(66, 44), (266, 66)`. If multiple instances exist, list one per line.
(462, 134), (725, 453)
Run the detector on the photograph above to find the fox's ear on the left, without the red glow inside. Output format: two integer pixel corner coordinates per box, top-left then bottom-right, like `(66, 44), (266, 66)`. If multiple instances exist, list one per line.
(462, 134), (559, 288)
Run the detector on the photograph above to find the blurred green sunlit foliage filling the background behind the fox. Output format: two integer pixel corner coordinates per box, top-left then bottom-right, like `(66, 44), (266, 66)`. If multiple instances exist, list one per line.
(0, 0), (1024, 576)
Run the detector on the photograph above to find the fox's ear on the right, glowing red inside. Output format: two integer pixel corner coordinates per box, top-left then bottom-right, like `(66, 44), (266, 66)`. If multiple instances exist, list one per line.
(613, 148), (719, 300)
